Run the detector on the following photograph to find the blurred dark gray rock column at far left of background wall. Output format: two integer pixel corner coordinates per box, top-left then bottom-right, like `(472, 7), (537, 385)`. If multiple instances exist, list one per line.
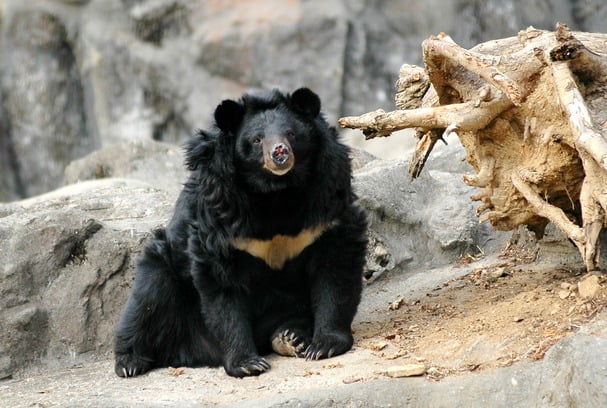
(0, 5), (96, 196)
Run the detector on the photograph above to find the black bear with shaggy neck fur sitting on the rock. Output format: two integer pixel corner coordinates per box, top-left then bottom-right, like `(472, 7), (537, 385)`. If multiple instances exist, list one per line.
(114, 88), (367, 377)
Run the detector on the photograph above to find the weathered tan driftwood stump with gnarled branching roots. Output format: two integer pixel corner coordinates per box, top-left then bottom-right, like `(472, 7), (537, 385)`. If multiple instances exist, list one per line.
(339, 24), (607, 271)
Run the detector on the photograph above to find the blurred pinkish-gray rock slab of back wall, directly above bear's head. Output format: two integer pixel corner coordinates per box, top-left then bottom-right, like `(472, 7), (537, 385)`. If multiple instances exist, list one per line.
(197, 0), (347, 121)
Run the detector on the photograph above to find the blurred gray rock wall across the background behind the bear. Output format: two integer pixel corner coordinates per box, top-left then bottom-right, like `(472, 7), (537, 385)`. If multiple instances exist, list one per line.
(0, 0), (607, 201)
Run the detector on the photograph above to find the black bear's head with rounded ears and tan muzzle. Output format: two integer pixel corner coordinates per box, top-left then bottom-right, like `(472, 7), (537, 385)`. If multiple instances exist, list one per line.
(215, 88), (329, 192)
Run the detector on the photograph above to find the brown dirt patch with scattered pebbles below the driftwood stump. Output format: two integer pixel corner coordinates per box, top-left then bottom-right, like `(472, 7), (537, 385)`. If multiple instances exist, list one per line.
(356, 253), (607, 379)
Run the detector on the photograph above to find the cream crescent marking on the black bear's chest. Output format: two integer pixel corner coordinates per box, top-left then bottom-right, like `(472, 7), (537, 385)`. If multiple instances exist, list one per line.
(232, 223), (335, 269)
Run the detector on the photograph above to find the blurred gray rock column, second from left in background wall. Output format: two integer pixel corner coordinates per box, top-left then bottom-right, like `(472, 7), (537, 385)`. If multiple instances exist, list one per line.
(75, 0), (163, 146)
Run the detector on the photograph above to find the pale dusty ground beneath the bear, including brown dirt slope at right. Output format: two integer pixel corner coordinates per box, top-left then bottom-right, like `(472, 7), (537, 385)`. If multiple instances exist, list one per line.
(0, 253), (607, 407)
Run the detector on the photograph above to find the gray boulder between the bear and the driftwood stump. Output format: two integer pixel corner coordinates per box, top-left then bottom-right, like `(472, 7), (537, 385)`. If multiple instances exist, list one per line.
(354, 139), (510, 275)
